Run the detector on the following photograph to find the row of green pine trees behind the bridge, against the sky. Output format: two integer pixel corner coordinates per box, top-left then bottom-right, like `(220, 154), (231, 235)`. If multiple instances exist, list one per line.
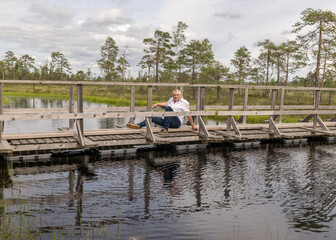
(0, 8), (336, 87)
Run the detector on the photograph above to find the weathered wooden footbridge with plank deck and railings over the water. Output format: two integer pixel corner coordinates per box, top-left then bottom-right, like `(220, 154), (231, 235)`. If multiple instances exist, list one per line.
(0, 80), (336, 155)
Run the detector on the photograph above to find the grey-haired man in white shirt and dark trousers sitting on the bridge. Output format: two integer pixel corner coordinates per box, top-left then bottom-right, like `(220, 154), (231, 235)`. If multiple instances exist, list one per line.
(126, 89), (198, 134)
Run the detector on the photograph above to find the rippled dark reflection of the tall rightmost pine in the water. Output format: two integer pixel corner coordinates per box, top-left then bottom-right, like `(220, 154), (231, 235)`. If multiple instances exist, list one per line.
(282, 143), (336, 231)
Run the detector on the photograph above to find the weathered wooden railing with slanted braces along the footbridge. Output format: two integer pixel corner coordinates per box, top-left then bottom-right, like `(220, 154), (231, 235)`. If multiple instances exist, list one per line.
(0, 80), (336, 144)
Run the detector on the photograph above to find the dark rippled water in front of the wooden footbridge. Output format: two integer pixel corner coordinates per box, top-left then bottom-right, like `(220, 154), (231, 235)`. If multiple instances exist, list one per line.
(0, 96), (336, 239)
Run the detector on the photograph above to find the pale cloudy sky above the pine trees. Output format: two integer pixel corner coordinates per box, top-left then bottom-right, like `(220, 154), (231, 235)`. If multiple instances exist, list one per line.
(0, 0), (336, 76)
